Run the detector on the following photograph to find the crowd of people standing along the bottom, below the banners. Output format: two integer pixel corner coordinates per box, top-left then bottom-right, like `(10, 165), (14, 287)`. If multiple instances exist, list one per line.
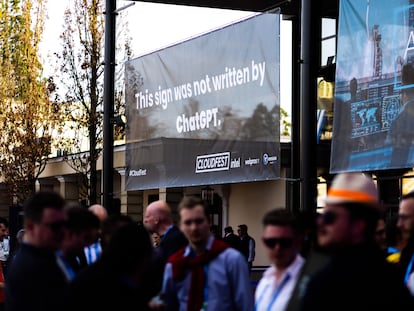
(0, 173), (414, 311)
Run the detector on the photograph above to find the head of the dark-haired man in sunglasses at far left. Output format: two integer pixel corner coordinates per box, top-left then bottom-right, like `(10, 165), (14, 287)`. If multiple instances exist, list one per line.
(23, 192), (66, 250)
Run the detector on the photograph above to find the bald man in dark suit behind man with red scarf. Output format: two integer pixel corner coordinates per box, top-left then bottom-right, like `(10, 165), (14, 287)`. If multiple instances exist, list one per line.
(144, 200), (188, 295)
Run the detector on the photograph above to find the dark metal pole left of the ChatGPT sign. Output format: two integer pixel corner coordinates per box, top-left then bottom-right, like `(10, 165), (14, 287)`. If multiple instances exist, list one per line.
(102, 0), (116, 212)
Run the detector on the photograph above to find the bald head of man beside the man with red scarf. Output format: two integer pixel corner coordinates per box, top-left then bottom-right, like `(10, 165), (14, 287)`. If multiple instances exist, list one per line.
(144, 200), (173, 235)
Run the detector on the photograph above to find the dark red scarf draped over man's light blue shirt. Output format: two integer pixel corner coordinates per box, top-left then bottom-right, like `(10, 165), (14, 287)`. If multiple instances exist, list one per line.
(168, 239), (229, 311)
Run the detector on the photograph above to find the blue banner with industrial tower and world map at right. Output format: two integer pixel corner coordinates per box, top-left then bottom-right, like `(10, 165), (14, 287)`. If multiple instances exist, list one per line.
(331, 0), (414, 173)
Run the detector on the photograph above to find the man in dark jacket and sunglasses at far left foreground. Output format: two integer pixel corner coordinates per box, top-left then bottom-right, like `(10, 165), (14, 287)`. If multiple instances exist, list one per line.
(6, 192), (67, 311)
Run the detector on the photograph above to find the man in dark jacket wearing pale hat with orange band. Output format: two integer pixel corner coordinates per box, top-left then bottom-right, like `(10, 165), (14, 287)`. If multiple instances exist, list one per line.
(287, 173), (414, 311)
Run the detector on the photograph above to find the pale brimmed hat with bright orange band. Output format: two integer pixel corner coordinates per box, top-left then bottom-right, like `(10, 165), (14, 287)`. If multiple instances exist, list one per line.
(325, 173), (380, 206)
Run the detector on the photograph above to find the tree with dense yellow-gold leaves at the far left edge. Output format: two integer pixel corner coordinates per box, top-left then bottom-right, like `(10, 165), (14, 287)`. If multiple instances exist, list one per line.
(0, 0), (61, 203)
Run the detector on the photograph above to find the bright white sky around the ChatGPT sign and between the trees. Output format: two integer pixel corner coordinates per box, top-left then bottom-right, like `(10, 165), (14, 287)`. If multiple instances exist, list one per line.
(41, 0), (291, 115)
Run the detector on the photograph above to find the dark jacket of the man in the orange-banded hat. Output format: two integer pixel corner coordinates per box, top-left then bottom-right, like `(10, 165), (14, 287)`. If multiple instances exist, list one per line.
(287, 245), (414, 311)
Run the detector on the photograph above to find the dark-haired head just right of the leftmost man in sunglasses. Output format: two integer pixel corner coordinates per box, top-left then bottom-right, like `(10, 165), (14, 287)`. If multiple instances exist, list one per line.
(61, 206), (100, 255)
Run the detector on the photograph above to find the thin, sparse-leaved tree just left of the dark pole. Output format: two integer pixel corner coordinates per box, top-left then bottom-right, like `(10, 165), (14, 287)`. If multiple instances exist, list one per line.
(56, 0), (131, 204)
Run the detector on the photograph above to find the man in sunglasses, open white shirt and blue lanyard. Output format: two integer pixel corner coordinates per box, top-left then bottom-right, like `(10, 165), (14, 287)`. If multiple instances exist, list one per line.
(255, 209), (305, 311)
